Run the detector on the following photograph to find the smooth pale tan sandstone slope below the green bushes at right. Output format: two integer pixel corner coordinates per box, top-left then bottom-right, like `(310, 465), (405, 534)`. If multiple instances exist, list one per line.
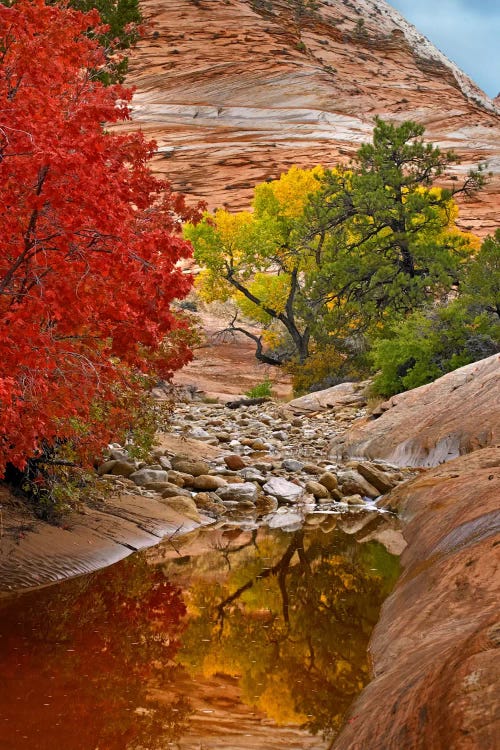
(331, 354), (500, 467)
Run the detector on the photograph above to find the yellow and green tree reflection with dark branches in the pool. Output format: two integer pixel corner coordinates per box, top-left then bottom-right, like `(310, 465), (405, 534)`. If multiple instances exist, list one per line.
(174, 531), (397, 735)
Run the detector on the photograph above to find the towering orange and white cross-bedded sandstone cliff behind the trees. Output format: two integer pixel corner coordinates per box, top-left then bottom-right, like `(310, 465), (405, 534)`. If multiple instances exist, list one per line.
(118, 0), (500, 234)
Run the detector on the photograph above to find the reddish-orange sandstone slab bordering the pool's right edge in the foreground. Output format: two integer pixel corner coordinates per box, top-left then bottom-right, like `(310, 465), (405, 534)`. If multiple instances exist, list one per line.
(333, 448), (500, 750)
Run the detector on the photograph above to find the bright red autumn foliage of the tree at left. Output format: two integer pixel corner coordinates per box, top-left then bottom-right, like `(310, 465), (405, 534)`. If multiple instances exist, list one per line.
(0, 0), (199, 475)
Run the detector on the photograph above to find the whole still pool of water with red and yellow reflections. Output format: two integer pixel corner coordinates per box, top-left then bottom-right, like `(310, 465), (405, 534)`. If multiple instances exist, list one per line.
(0, 517), (398, 750)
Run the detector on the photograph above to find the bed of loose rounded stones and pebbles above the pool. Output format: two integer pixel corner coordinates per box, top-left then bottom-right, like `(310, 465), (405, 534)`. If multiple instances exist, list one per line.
(98, 390), (410, 529)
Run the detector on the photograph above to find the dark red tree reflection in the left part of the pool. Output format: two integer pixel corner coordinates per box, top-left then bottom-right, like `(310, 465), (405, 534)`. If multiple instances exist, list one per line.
(0, 556), (190, 750)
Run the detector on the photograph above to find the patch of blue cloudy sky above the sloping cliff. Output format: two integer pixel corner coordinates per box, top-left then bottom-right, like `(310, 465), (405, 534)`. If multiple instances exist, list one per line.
(388, 0), (500, 96)
